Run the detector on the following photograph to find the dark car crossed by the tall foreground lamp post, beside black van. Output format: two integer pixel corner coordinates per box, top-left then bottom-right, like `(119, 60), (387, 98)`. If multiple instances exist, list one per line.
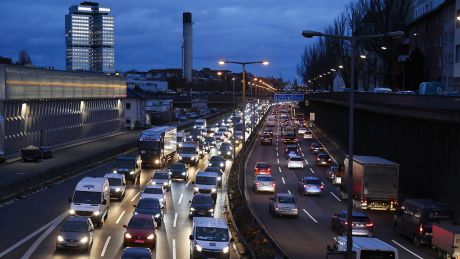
(331, 210), (374, 237)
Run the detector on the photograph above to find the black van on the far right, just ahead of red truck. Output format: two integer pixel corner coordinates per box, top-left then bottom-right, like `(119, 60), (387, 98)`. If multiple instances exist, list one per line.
(394, 199), (455, 245)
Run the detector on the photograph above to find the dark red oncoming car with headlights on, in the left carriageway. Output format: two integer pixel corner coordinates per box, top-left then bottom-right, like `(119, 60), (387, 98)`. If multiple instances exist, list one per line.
(123, 214), (157, 248)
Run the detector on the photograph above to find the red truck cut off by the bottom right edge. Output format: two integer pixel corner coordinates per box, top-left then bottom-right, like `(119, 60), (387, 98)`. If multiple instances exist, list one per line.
(431, 224), (460, 259)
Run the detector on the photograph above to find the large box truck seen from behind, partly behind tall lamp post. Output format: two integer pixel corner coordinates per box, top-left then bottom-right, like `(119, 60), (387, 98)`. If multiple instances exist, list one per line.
(340, 156), (399, 210)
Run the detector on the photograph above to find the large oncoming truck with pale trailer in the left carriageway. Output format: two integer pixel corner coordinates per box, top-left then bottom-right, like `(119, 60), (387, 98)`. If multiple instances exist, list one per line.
(137, 126), (177, 168)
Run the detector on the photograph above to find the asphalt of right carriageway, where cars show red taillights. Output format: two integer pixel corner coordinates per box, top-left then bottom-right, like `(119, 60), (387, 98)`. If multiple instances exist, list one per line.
(245, 110), (435, 259)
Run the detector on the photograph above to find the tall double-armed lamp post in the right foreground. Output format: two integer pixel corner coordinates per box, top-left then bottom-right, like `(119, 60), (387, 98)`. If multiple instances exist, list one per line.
(302, 30), (404, 259)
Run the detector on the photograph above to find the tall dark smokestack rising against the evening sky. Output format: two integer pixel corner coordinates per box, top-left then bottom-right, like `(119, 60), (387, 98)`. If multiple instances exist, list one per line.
(182, 12), (192, 83)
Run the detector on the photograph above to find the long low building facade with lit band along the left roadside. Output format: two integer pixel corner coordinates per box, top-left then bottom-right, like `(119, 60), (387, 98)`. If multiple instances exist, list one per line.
(0, 65), (126, 155)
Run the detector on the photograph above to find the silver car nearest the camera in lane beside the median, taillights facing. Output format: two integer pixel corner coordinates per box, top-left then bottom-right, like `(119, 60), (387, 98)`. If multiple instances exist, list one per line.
(268, 193), (299, 218)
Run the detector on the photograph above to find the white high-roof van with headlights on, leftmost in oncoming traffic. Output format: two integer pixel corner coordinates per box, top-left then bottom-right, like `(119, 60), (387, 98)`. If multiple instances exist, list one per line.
(69, 177), (110, 229)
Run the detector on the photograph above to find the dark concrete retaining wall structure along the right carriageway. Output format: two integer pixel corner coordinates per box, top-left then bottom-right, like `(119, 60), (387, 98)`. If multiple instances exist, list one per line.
(302, 92), (460, 219)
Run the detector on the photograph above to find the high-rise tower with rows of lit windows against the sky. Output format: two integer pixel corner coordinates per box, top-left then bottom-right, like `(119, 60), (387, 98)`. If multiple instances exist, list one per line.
(65, 2), (115, 72)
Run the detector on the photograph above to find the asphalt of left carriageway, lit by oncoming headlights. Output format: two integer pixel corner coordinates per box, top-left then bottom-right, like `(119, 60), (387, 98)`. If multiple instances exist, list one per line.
(0, 112), (248, 259)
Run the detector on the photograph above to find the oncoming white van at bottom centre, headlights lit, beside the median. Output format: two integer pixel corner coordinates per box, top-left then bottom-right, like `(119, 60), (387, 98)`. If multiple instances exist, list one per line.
(190, 217), (233, 258)
